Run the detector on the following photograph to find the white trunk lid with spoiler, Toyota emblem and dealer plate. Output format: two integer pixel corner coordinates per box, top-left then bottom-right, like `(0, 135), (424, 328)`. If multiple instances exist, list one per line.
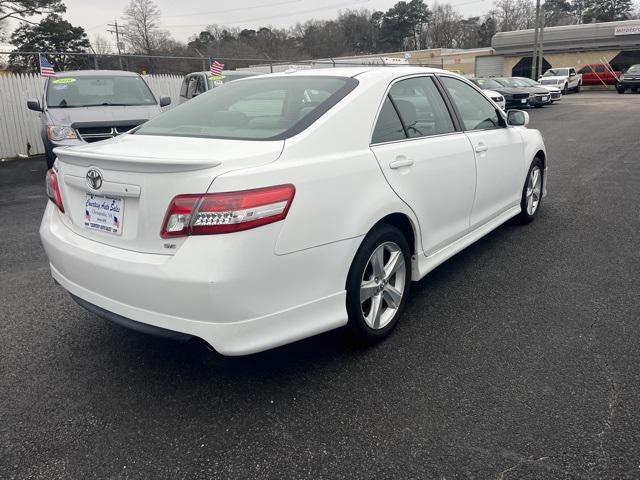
(55, 135), (284, 255)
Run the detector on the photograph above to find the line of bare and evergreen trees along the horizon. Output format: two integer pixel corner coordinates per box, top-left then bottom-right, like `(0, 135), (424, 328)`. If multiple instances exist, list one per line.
(0, 0), (638, 73)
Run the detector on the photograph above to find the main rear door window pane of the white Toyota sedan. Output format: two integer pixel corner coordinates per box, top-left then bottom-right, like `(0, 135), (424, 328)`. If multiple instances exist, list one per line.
(389, 77), (455, 137)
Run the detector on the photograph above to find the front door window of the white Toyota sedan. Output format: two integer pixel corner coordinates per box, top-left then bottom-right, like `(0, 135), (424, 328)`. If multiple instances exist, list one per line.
(440, 77), (501, 130)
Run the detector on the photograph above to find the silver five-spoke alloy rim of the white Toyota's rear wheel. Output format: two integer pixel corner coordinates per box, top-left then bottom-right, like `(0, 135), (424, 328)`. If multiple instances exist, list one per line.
(360, 242), (407, 330)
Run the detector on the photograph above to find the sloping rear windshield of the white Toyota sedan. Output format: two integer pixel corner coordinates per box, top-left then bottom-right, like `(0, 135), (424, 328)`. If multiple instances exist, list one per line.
(135, 76), (358, 140)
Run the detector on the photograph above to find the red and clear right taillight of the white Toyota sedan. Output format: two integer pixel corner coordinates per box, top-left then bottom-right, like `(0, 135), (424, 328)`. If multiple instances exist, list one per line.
(160, 185), (296, 238)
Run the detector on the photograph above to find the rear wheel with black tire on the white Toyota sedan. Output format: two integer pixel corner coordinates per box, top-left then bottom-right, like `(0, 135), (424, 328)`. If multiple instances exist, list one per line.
(346, 223), (411, 345)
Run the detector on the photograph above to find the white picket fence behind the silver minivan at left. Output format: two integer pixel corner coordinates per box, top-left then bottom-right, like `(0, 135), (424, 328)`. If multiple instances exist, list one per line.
(0, 74), (183, 159)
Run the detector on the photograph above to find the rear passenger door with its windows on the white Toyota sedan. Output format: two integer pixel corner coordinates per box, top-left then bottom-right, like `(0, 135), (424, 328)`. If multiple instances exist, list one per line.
(371, 76), (476, 255)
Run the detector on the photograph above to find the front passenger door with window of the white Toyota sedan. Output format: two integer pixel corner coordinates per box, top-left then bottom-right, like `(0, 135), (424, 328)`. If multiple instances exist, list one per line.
(439, 76), (525, 228)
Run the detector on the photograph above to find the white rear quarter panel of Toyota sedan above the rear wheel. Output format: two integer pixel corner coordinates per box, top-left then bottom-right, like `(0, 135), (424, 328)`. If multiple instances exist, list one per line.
(211, 76), (420, 255)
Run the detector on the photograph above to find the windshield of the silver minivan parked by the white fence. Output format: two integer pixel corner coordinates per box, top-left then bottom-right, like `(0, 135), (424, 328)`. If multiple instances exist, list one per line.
(47, 75), (156, 108)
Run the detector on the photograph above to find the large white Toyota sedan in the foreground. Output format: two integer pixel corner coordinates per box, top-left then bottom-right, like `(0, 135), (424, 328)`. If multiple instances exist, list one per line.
(40, 67), (547, 355)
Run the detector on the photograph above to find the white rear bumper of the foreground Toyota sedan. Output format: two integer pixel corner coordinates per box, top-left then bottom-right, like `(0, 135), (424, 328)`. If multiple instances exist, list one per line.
(40, 203), (361, 355)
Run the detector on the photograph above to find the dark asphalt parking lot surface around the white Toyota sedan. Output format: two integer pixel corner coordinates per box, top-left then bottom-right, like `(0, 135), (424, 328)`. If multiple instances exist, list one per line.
(0, 92), (640, 480)
